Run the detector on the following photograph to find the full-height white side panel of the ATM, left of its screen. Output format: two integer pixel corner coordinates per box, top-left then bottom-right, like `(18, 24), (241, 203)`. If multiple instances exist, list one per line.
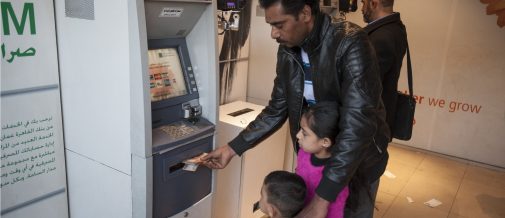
(55, 0), (132, 217)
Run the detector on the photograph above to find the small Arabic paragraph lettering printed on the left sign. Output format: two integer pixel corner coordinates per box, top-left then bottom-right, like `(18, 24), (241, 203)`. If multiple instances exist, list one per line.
(0, 116), (56, 188)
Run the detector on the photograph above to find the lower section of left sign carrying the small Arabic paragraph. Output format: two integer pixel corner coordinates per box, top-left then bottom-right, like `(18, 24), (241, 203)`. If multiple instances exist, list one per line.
(0, 87), (66, 213)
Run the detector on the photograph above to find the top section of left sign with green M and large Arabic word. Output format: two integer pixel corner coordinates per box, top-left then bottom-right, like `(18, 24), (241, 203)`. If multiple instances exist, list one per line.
(0, 0), (58, 91)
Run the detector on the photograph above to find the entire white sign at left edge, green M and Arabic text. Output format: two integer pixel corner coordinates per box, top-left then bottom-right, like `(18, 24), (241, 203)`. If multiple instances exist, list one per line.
(0, 0), (68, 218)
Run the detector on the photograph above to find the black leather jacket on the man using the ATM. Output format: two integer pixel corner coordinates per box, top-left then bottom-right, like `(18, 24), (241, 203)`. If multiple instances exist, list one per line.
(229, 14), (389, 201)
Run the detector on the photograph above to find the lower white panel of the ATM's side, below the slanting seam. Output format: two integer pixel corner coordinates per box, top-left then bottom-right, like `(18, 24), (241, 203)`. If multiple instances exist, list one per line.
(66, 150), (132, 218)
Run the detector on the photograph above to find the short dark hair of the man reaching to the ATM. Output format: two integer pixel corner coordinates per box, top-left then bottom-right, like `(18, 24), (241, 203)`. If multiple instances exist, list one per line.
(259, 0), (319, 19)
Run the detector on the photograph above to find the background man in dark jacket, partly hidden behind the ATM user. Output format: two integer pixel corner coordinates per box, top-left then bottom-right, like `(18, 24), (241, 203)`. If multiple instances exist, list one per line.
(361, 0), (407, 139)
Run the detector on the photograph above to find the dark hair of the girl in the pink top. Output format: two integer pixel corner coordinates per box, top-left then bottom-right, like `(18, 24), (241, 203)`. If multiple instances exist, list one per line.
(303, 101), (340, 145)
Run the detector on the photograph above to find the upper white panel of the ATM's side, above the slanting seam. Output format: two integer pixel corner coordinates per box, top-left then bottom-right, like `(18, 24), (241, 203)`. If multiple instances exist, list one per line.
(56, 0), (131, 174)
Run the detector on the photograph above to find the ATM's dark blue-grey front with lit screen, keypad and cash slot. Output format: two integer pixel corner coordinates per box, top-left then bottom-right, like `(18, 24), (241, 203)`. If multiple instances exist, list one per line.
(148, 38), (215, 217)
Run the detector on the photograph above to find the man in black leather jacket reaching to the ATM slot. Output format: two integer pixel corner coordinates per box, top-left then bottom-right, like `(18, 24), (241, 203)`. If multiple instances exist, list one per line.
(202, 0), (389, 218)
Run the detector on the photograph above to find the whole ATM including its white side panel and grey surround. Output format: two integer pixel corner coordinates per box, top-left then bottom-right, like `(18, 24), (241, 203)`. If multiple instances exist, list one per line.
(55, 0), (219, 218)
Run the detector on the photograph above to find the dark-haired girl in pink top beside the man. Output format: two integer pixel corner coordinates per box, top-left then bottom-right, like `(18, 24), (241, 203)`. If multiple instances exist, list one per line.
(296, 102), (349, 218)
